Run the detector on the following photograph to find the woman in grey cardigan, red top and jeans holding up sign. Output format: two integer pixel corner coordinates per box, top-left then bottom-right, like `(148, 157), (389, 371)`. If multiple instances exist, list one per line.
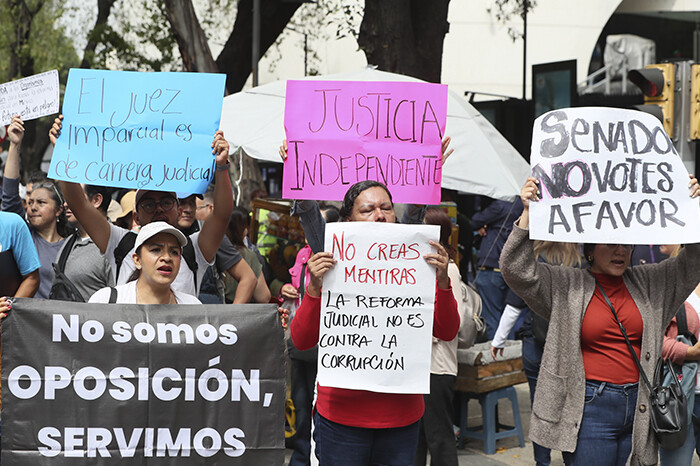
(500, 176), (700, 465)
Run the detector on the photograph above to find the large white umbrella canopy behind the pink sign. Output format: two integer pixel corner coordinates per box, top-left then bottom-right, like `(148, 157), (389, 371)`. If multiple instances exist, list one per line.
(221, 67), (530, 200)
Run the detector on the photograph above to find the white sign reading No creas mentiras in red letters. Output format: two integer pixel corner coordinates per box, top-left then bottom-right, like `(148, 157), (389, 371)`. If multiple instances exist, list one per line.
(318, 222), (439, 393)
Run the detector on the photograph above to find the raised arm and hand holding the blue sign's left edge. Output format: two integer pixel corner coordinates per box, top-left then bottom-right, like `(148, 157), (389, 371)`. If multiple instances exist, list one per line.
(49, 115), (110, 254)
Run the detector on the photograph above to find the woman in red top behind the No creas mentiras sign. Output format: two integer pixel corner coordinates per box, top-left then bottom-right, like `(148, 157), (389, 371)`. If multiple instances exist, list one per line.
(291, 181), (459, 466)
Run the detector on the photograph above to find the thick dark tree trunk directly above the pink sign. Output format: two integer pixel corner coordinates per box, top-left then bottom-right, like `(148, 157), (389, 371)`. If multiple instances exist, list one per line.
(358, 0), (450, 83)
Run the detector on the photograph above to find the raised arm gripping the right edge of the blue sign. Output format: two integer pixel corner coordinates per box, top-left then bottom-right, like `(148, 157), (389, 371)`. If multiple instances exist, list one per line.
(199, 131), (233, 262)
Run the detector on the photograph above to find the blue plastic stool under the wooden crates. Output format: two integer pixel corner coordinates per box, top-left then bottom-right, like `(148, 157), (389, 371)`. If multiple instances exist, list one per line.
(459, 387), (525, 455)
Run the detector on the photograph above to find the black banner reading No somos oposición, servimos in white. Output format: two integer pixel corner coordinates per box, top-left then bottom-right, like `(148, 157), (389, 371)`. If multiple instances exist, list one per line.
(2, 299), (285, 466)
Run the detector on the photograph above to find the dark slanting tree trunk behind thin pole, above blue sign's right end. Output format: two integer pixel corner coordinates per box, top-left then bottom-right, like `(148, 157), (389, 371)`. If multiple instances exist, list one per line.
(216, 0), (301, 94)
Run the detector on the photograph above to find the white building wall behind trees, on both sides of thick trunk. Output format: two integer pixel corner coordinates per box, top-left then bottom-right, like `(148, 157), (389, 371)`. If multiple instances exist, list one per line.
(248, 0), (700, 100)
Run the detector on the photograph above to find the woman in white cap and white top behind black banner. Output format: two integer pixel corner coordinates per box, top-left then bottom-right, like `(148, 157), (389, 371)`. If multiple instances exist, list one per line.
(89, 222), (201, 304)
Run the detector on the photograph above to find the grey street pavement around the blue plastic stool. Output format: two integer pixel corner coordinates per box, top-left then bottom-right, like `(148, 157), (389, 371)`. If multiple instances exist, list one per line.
(286, 383), (700, 466)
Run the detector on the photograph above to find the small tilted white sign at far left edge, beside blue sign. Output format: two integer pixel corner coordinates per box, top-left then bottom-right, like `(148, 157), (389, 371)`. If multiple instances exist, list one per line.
(0, 70), (59, 125)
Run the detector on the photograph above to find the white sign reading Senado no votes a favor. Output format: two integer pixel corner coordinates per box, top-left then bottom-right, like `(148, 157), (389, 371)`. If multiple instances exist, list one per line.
(530, 108), (700, 244)
